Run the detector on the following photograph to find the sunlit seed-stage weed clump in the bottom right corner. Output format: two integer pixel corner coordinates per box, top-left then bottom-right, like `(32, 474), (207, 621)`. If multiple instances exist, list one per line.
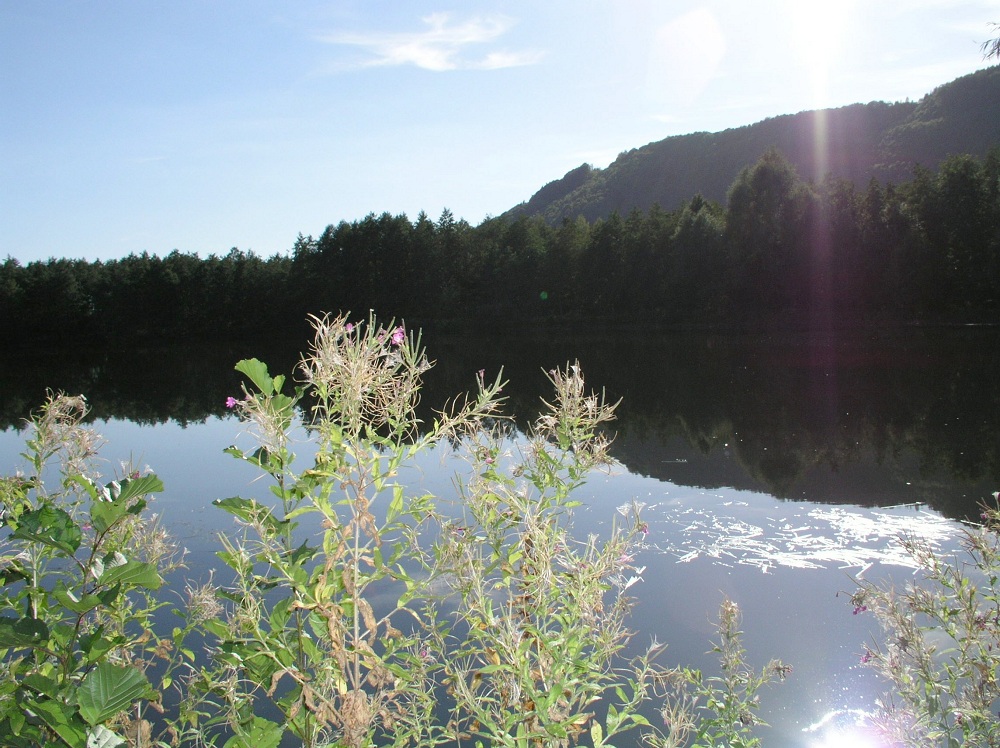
(851, 493), (1000, 748)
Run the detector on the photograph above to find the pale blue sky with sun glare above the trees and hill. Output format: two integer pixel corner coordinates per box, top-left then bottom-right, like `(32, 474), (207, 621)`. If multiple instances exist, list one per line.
(0, 0), (1000, 262)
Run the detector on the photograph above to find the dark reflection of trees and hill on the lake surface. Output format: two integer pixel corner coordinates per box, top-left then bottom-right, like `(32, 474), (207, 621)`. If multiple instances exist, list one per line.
(0, 328), (1000, 518)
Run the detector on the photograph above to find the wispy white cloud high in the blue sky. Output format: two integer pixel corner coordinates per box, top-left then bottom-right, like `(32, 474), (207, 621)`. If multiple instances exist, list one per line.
(320, 13), (542, 72)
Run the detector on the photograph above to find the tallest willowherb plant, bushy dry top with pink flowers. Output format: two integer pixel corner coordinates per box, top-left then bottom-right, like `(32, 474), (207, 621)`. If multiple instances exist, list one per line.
(193, 317), (508, 746)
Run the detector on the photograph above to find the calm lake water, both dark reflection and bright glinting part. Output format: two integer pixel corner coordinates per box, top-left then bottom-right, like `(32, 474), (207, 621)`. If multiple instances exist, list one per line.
(0, 328), (1000, 748)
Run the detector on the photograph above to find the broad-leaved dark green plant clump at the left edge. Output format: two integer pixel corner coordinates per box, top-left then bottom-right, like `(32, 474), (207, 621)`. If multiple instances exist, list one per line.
(0, 395), (193, 748)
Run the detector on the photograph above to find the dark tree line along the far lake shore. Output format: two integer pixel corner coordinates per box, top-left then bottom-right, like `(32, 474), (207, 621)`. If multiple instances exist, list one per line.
(0, 148), (1000, 343)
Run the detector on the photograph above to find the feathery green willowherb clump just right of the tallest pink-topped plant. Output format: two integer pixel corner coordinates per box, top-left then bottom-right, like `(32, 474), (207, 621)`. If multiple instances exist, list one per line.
(436, 364), (660, 746)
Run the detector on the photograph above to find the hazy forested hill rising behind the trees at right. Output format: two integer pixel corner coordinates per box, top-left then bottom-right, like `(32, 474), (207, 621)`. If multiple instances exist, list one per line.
(505, 65), (1000, 225)
